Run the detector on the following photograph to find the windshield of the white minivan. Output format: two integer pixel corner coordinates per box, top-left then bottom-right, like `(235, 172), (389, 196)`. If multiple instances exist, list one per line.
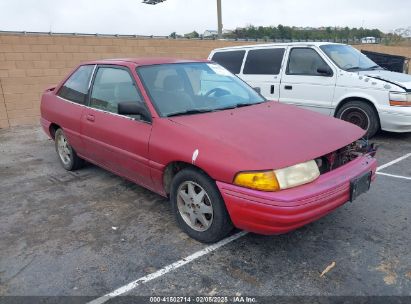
(320, 44), (382, 71)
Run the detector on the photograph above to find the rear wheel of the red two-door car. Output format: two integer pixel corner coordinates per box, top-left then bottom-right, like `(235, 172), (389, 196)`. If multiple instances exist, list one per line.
(54, 129), (84, 171)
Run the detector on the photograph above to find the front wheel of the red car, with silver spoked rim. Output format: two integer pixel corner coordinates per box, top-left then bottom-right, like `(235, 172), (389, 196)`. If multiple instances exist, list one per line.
(170, 168), (233, 243)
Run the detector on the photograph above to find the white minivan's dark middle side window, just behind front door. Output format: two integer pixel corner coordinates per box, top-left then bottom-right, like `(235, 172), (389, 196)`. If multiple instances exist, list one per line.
(243, 49), (285, 75)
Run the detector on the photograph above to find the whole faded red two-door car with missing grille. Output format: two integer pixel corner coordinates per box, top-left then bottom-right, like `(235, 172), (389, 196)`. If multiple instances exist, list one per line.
(41, 58), (376, 242)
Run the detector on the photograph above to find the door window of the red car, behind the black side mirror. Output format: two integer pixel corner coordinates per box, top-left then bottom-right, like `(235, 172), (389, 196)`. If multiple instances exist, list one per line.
(90, 67), (143, 113)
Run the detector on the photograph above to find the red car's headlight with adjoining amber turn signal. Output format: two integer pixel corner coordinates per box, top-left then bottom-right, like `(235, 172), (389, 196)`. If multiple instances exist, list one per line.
(234, 160), (320, 191)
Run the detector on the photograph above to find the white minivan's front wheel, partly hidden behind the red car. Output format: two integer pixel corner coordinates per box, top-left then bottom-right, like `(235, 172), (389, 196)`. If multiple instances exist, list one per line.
(336, 100), (380, 138)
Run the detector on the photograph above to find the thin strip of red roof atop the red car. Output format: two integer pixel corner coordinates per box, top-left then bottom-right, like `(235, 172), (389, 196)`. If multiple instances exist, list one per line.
(82, 57), (209, 66)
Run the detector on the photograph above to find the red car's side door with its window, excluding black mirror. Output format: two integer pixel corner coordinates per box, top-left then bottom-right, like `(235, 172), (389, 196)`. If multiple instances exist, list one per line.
(81, 65), (152, 188)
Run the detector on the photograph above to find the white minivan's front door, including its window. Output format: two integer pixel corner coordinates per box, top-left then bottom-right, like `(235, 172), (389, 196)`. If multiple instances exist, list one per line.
(280, 47), (336, 115)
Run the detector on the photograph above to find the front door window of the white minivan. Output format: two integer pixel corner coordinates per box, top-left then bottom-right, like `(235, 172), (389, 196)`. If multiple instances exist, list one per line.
(286, 48), (329, 76)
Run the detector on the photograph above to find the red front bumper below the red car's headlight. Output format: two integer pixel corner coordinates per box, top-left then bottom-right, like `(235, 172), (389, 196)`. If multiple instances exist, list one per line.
(217, 156), (377, 235)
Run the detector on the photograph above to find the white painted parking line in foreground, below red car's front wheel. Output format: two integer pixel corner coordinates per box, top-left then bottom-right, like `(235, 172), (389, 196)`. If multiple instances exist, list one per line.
(88, 231), (248, 304)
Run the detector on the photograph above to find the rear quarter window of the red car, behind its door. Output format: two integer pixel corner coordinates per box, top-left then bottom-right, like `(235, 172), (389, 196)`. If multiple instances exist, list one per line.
(57, 65), (94, 105)
